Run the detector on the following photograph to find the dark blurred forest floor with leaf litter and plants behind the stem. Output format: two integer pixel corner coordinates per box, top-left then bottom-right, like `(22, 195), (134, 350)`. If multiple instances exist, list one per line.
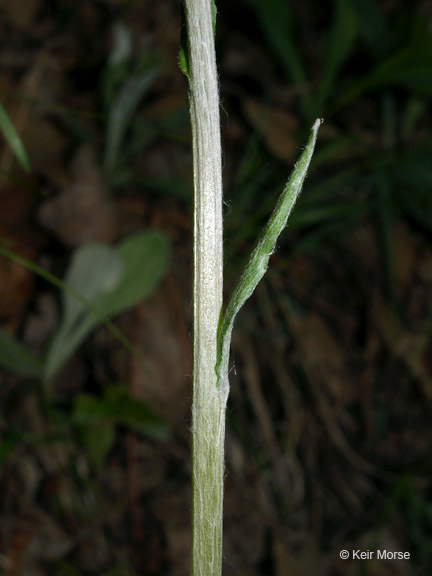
(0, 0), (432, 576)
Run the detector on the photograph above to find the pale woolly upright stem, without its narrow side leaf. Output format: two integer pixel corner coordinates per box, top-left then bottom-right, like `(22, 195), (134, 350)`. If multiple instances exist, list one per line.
(185, 0), (228, 576)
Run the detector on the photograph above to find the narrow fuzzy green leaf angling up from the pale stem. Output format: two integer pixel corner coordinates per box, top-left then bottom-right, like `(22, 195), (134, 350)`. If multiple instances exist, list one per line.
(216, 119), (322, 390)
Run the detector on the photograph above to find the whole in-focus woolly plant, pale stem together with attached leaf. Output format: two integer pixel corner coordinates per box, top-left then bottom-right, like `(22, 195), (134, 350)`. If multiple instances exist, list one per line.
(179, 0), (321, 576)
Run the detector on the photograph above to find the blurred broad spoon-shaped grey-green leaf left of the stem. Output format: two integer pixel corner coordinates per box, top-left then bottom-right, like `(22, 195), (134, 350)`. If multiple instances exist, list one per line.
(44, 232), (169, 379)
